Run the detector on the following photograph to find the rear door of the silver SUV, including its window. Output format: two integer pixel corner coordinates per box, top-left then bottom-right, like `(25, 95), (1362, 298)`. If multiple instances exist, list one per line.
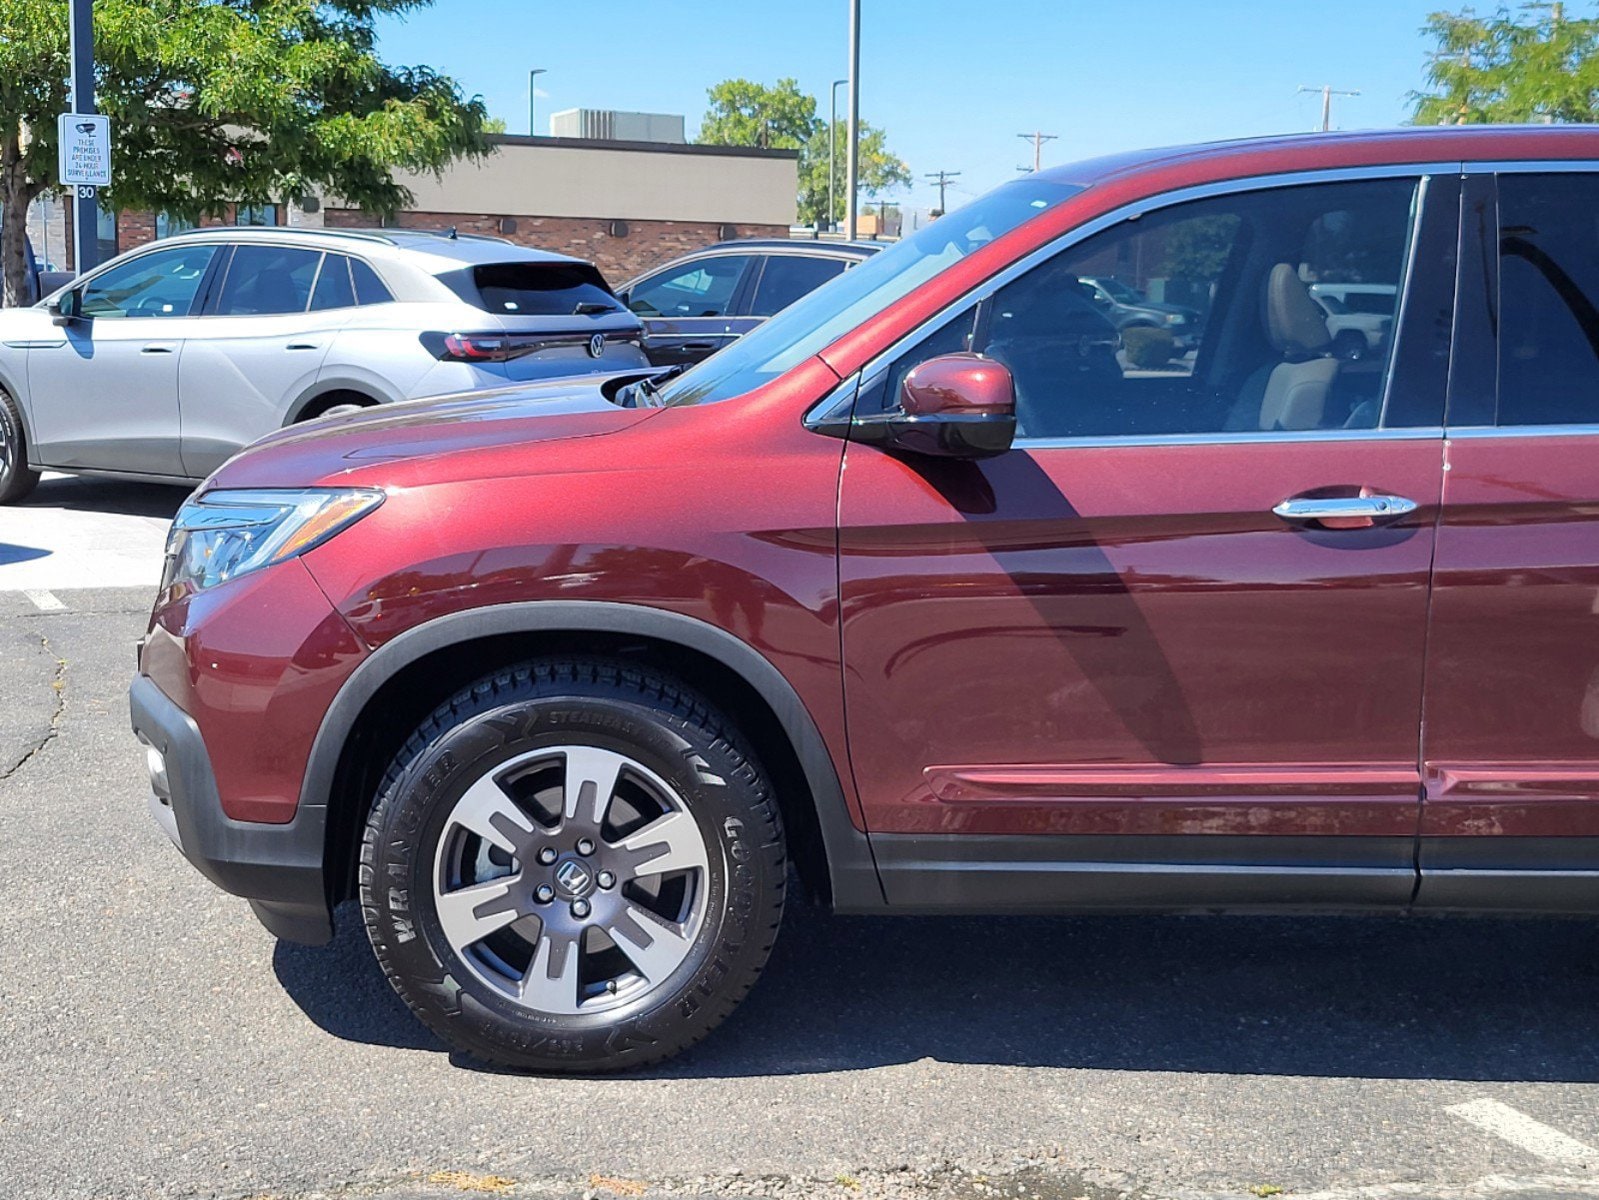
(177, 243), (352, 475)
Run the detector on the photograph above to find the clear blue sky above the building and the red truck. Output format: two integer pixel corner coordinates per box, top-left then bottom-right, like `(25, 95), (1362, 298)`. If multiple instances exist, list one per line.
(381, 0), (1464, 214)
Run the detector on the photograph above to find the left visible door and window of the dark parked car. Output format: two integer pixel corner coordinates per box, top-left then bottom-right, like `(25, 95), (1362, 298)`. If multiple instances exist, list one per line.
(627, 254), (760, 366)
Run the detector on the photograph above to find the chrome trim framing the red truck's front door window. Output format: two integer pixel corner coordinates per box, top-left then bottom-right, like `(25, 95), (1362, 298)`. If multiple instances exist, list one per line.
(860, 158), (1463, 450)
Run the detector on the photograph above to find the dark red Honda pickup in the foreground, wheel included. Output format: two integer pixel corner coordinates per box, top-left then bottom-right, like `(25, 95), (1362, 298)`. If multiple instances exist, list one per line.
(133, 128), (1599, 1070)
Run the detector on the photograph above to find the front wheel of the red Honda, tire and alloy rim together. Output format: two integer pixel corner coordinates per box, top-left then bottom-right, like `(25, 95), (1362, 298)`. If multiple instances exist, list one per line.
(360, 659), (785, 1072)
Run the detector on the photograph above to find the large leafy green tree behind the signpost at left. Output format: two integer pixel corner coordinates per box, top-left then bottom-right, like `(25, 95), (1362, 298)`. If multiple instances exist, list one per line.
(0, 0), (484, 302)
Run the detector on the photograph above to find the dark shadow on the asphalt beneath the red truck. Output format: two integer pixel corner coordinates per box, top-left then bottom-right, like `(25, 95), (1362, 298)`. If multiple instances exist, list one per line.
(273, 906), (1599, 1083)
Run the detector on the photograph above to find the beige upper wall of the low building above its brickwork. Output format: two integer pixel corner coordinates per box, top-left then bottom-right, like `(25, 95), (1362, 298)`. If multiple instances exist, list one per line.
(397, 136), (800, 226)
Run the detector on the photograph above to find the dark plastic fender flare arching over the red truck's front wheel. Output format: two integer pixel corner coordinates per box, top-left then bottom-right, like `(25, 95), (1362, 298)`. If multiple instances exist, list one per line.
(299, 600), (884, 912)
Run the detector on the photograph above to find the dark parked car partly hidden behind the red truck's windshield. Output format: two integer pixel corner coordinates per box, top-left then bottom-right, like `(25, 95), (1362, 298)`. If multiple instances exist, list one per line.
(619, 238), (883, 366)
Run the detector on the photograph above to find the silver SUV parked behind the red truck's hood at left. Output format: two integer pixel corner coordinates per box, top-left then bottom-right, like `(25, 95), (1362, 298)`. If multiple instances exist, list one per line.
(0, 227), (646, 502)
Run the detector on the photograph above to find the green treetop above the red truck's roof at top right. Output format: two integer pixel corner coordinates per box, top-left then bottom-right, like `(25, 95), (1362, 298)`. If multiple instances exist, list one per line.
(1410, 3), (1599, 125)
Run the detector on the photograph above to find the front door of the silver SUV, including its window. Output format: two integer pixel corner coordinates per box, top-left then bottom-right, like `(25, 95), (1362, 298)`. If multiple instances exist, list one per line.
(27, 243), (217, 475)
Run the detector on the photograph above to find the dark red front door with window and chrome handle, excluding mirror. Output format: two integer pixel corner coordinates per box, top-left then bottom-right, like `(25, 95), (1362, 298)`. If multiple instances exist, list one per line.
(839, 167), (1458, 907)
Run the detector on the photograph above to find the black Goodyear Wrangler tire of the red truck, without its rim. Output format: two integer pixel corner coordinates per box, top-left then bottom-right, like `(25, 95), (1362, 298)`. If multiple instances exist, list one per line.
(360, 658), (787, 1074)
